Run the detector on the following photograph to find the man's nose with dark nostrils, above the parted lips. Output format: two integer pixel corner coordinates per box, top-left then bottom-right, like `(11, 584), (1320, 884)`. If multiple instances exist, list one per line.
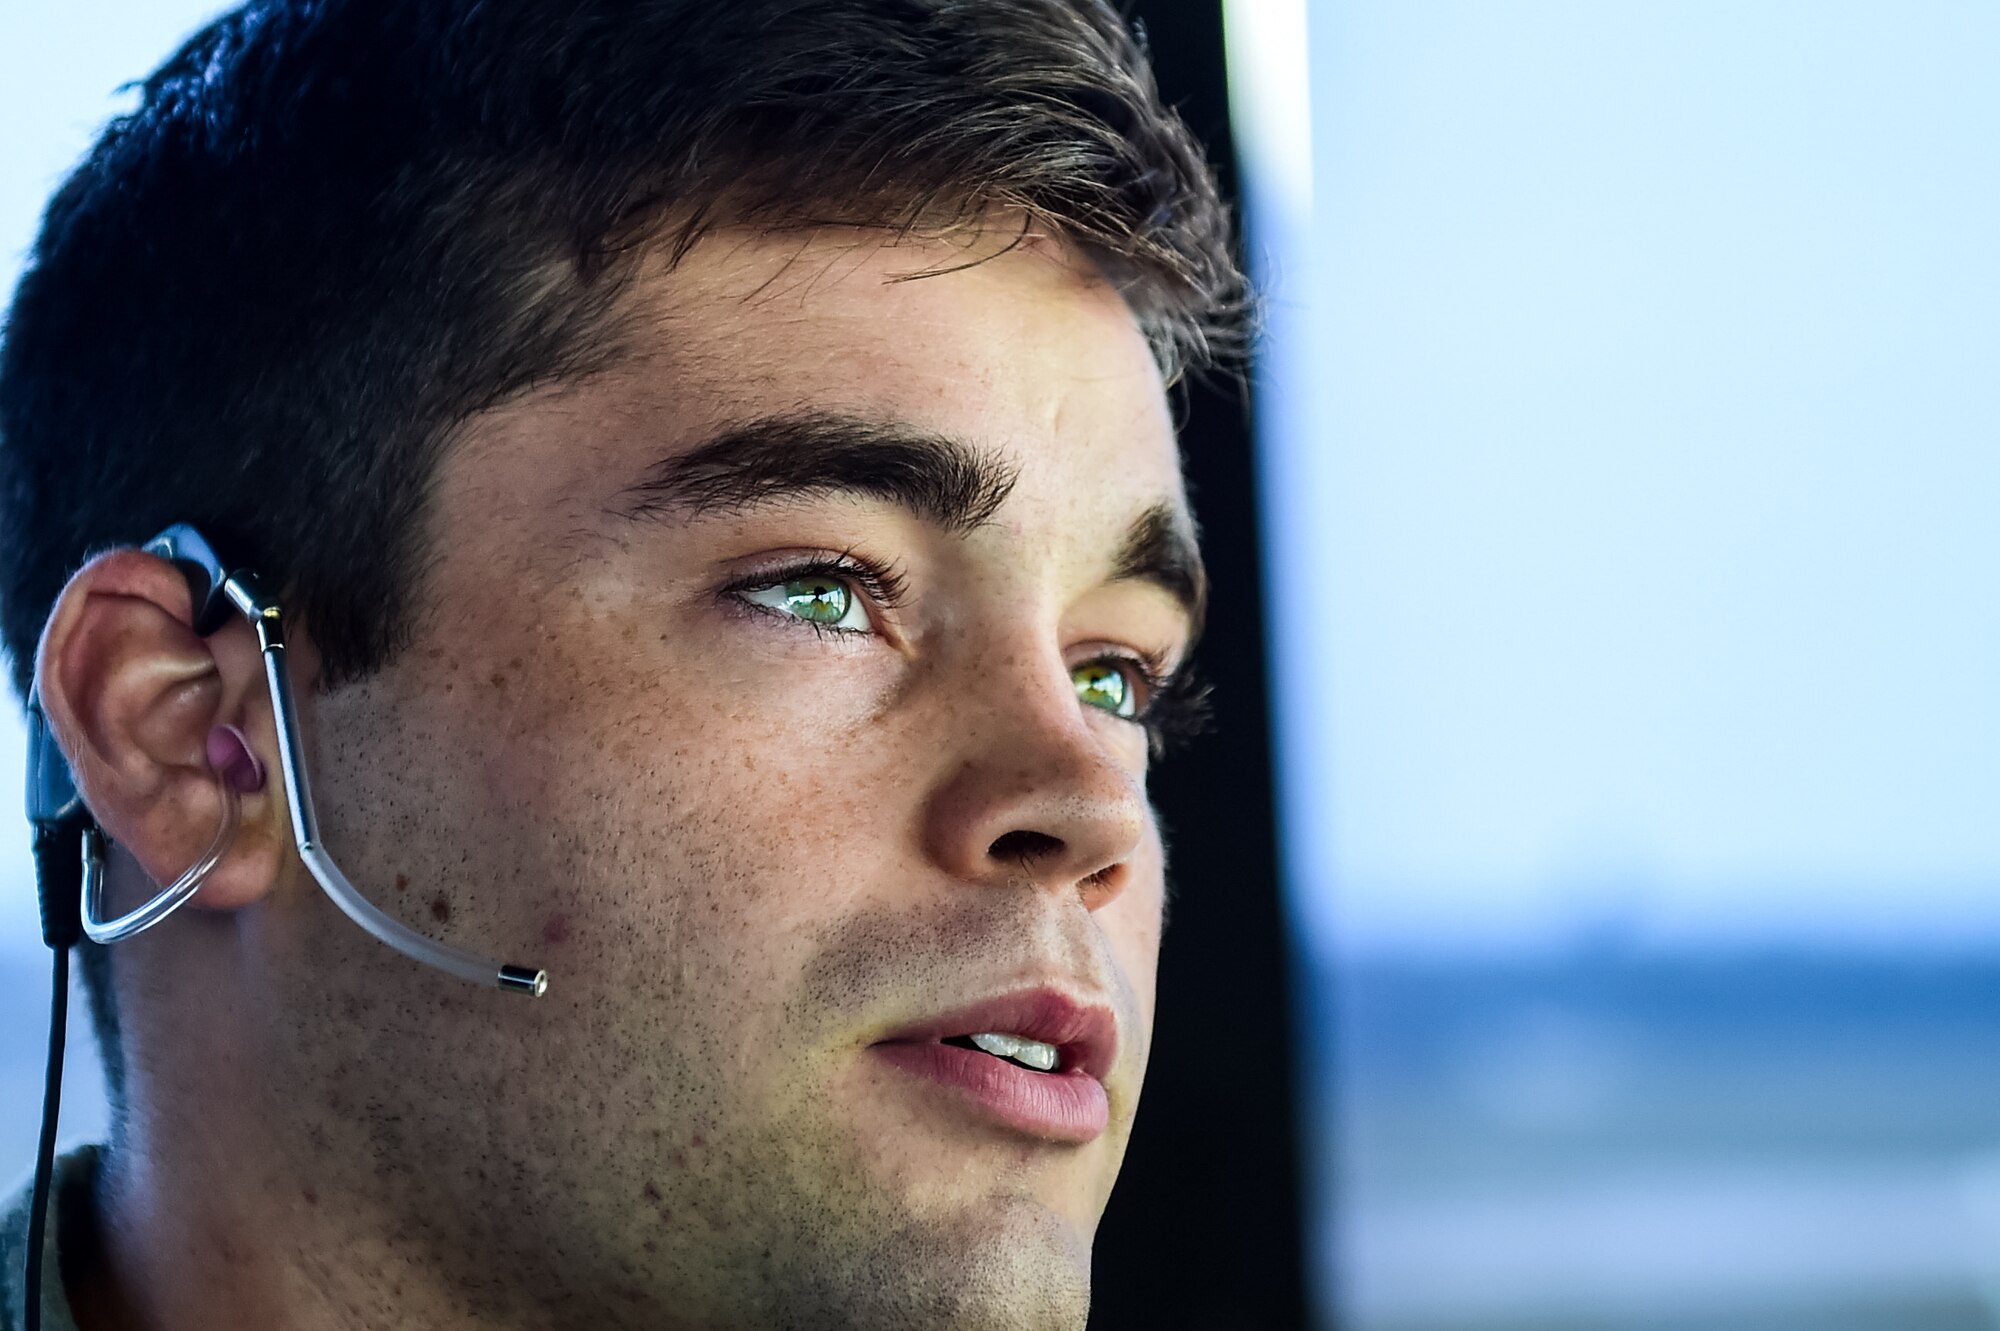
(924, 660), (1150, 909)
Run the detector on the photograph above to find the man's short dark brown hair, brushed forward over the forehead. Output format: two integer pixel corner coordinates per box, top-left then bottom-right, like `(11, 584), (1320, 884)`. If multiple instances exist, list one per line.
(0, 0), (1240, 1077)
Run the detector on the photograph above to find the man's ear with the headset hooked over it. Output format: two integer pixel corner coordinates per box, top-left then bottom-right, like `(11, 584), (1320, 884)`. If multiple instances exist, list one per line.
(34, 550), (290, 909)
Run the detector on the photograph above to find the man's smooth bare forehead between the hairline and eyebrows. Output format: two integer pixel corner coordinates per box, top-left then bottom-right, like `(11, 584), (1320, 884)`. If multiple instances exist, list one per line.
(572, 228), (1182, 522)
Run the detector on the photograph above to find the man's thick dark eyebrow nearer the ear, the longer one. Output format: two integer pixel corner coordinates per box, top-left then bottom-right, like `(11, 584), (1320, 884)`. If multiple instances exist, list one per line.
(620, 412), (1020, 536)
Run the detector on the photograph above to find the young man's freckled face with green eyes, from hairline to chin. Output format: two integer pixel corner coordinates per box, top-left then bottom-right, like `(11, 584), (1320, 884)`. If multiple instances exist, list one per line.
(272, 234), (1198, 1327)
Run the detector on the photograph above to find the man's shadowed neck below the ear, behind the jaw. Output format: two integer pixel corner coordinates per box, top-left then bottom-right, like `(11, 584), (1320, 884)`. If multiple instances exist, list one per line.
(64, 911), (524, 1331)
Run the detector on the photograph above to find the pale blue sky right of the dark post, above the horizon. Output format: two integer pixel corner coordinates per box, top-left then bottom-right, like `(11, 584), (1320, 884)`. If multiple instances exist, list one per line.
(1236, 0), (2000, 947)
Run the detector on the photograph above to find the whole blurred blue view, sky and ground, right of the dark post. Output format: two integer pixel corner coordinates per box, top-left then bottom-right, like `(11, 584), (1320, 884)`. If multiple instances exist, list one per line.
(1230, 0), (2000, 1331)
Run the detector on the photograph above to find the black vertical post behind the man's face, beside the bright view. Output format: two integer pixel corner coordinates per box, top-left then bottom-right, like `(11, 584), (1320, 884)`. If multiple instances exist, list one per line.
(1090, 0), (1308, 1331)
